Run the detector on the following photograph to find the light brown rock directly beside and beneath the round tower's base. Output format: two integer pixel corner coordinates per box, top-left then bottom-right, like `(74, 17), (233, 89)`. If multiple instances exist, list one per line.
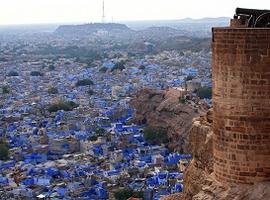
(163, 110), (270, 200)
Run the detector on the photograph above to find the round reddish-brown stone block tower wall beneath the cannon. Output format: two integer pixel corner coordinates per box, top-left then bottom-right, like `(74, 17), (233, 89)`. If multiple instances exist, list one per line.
(212, 27), (270, 184)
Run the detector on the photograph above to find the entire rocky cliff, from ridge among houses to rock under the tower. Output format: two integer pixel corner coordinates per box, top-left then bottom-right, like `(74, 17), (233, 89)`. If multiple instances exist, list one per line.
(131, 89), (270, 200)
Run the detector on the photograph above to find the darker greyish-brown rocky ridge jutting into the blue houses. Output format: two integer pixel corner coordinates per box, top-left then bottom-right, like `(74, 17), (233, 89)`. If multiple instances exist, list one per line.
(131, 89), (206, 152)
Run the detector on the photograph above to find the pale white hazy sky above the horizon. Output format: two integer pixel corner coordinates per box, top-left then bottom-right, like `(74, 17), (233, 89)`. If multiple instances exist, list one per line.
(0, 0), (270, 24)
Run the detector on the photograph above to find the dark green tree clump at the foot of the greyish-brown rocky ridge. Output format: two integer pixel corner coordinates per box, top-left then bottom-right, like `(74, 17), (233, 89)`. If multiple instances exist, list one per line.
(144, 126), (169, 145)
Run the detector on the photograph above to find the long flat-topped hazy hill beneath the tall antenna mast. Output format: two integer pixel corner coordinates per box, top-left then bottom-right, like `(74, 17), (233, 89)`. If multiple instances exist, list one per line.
(55, 23), (131, 35)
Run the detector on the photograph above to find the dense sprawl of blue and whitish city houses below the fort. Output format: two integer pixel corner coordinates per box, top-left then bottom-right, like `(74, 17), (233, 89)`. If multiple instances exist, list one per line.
(0, 34), (211, 199)
